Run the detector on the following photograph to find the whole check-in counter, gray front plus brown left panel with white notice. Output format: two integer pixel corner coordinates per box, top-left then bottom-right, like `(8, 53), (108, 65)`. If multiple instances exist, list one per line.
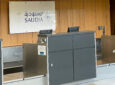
(23, 32), (96, 85)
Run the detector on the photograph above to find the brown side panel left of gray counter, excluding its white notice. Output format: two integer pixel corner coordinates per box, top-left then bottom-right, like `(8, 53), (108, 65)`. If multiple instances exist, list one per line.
(23, 44), (47, 78)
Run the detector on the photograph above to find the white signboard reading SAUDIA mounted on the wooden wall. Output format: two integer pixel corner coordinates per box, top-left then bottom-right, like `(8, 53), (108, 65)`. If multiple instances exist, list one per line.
(9, 1), (56, 34)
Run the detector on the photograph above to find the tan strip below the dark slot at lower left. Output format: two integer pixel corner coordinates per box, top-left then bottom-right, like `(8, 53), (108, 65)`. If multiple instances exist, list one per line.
(4, 72), (23, 81)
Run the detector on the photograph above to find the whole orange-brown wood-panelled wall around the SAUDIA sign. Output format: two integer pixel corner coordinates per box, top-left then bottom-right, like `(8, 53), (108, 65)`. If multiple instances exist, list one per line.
(0, 0), (111, 46)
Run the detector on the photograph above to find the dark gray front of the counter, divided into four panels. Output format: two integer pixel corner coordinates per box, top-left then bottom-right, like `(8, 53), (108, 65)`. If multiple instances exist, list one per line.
(46, 31), (96, 85)
